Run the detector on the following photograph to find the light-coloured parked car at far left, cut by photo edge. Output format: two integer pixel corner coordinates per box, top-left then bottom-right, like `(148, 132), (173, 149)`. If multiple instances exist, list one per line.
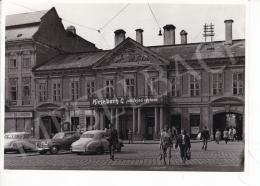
(4, 132), (37, 153)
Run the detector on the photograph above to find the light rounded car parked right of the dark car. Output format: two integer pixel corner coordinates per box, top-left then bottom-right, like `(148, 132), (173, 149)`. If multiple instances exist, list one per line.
(71, 130), (124, 154)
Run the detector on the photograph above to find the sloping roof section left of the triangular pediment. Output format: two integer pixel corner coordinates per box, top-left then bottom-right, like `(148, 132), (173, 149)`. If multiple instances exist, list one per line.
(35, 51), (108, 71)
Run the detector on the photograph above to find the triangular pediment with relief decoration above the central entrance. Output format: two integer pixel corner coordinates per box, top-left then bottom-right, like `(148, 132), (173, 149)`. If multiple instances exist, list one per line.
(94, 37), (170, 68)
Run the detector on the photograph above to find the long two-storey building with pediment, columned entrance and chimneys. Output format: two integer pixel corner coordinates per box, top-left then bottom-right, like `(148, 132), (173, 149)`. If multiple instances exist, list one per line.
(33, 20), (245, 140)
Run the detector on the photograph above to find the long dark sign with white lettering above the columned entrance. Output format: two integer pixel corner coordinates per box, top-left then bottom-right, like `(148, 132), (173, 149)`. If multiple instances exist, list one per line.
(91, 97), (160, 106)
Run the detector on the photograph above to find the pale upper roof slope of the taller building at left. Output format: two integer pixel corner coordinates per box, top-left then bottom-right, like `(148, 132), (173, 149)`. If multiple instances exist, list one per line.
(6, 10), (47, 28)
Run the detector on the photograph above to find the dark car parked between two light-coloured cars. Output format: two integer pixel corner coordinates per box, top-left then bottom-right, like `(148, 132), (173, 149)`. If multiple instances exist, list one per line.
(37, 131), (80, 154)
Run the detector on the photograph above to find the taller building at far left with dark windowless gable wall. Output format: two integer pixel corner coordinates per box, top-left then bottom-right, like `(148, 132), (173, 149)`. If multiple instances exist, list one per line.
(5, 8), (98, 137)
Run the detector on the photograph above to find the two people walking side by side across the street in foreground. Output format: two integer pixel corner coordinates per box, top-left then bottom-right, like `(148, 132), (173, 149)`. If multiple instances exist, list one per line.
(160, 128), (191, 164)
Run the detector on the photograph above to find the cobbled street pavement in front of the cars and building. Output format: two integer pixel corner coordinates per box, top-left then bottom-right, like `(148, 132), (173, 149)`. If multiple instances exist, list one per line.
(4, 141), (244, 171)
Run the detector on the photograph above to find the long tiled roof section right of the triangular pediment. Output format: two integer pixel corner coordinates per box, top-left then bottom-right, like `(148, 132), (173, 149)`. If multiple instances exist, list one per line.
(148, 40), (245, 60)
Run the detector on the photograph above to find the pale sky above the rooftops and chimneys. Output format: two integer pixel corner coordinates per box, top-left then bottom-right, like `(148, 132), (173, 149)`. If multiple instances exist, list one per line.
(4, 0), (245, 49)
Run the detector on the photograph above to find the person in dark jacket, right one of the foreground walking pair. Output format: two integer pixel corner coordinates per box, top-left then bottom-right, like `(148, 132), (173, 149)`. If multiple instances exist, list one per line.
(175, 130), (191, 164)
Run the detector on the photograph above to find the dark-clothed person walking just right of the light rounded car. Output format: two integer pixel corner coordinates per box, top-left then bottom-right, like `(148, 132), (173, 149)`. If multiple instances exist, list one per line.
(107, 123), (118, 161)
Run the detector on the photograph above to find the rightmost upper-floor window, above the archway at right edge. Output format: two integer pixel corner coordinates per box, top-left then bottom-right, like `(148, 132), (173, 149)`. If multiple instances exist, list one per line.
(233, 72), (244, 95)
